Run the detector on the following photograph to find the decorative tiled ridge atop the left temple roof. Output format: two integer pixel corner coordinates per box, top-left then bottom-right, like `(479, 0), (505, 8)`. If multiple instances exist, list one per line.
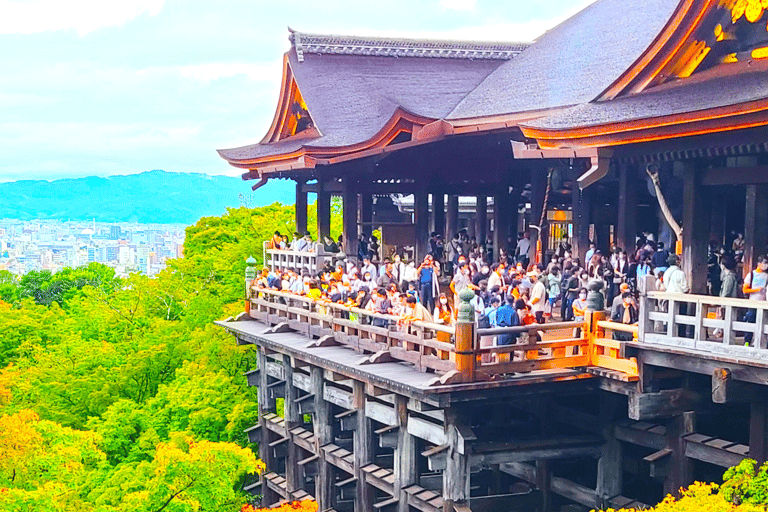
(288, 28), (530, 62)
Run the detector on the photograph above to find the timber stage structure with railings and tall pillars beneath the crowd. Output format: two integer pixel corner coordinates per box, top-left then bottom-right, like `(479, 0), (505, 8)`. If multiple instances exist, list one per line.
(218, 278), (768, 512)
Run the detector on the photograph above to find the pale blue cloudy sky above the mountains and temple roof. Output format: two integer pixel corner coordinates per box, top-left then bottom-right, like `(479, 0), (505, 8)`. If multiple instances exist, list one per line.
(0, 0), (592, 181)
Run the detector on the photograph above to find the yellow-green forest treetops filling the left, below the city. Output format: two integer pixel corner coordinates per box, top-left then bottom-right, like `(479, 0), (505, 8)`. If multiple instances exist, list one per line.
(0, 204), (320, 512)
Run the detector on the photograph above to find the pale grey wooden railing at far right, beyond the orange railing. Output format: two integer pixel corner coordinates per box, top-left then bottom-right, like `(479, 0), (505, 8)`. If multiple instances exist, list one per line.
(638, 291), (768, 360)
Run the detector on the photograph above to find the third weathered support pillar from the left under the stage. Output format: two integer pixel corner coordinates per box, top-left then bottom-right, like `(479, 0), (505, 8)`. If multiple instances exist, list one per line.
(310, 366), (336, 510)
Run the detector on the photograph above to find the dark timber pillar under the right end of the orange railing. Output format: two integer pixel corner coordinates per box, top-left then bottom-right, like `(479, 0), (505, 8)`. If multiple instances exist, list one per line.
(595, 392), (624, 508)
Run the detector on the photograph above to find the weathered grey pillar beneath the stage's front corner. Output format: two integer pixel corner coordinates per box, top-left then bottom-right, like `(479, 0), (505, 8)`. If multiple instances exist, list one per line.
(443, 408), (471, 512)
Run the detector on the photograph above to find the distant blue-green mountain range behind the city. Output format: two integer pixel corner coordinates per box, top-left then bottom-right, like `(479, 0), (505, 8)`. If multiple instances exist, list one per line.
(0, 171), (295, 224)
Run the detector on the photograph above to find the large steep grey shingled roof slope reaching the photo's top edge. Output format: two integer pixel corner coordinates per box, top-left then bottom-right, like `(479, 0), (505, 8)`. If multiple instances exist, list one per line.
(448, 0), (679, 119)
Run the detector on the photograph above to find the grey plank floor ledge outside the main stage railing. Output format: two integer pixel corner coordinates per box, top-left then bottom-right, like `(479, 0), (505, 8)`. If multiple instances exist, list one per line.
(216, 320), (593, 400)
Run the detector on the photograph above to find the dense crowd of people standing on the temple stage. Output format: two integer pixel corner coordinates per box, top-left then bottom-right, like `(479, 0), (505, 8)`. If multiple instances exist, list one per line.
(258, 226), (768, 344)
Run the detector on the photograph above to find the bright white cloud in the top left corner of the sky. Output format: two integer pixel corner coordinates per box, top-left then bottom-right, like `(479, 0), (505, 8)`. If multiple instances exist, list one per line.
(0, 0), (164, 34)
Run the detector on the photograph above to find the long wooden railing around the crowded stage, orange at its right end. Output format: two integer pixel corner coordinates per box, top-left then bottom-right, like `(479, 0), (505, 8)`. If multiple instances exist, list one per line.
(250, 287), (637, 384)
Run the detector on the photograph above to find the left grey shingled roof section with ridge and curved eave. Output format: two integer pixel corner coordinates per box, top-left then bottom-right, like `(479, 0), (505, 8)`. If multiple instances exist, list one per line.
(219, 32), (526, 160)
